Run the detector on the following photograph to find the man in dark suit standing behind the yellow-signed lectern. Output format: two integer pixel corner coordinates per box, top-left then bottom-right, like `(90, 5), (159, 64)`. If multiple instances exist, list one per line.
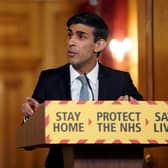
(22, 12), (142, 168)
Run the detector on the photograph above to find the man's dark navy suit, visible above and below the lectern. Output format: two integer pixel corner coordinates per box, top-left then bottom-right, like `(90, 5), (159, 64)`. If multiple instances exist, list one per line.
(32, 64), (142, 168)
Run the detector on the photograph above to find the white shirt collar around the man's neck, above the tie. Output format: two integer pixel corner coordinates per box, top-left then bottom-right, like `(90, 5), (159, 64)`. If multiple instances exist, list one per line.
(70, 62), (99, 84)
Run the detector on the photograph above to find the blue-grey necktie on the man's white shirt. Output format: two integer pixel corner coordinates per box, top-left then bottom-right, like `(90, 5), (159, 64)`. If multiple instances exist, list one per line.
(77, 75), (89, 100)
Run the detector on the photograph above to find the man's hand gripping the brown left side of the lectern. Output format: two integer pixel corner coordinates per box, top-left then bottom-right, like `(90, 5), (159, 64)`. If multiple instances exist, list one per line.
(22, 97), (39, 118)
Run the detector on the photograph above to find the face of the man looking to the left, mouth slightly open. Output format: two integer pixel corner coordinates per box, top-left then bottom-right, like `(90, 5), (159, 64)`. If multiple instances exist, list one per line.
(67, 24), (97, 71)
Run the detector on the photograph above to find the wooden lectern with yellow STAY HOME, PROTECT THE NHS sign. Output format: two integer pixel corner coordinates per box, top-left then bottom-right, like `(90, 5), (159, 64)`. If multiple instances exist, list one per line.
(17, 101), (168, 168)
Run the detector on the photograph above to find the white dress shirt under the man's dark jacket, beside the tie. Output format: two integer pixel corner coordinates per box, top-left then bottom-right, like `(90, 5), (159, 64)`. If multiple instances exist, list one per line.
(70, 62), (99, 100)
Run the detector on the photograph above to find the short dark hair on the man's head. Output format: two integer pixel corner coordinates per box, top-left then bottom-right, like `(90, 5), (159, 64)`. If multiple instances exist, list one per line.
(67, 12), (109, 42)
